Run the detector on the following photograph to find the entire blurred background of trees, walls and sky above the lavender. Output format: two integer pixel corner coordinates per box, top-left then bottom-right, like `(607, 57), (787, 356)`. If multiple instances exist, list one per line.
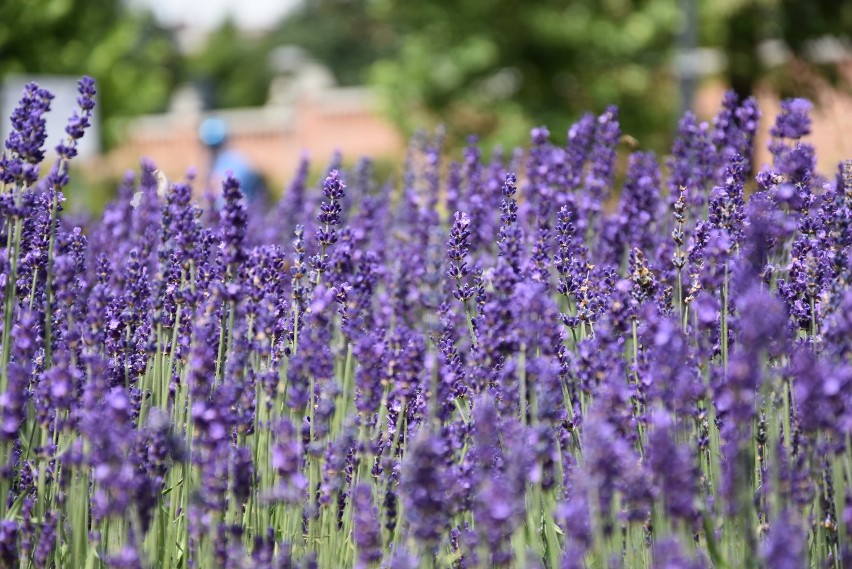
(0, 0), (852, 209)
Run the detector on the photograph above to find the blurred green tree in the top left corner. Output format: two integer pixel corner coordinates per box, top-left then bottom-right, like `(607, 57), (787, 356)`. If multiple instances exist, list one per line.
(0, 0), (181, 146)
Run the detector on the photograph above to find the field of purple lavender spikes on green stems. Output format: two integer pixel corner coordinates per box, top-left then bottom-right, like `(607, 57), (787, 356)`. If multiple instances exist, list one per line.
(0, 78), (852, 569)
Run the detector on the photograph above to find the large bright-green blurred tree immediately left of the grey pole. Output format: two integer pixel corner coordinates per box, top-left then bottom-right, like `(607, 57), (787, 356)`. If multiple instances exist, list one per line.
(373, 0), (678, 150)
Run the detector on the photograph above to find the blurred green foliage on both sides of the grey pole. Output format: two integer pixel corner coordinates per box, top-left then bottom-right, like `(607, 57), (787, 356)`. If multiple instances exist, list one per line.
(369, 0), (852, 148)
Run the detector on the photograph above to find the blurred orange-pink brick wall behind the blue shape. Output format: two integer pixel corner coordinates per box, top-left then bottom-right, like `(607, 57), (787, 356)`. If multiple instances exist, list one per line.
(100, 88), (405, 188)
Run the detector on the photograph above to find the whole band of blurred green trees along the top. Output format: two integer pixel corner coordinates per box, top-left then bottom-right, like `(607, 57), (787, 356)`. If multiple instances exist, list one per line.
(0, 0), (852, 149)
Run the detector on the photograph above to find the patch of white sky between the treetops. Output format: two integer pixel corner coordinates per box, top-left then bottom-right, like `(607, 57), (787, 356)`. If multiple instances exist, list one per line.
(127, 0), (300, 29)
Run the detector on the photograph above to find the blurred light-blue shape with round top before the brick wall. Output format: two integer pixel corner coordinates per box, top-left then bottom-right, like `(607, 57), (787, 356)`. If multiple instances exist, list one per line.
(198, 117), (266, 202)
